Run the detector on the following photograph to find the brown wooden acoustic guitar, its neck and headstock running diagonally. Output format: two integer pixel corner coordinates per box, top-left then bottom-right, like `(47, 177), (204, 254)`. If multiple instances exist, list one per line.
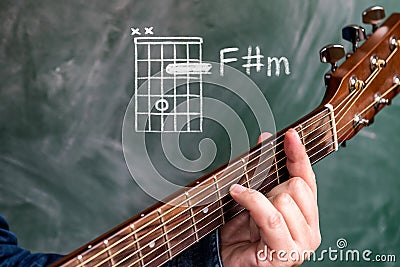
(52, 7), (400, 267)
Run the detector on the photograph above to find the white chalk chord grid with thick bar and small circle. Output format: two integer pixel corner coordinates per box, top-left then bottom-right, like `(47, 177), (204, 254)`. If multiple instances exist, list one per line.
(134, 37), (211, 132)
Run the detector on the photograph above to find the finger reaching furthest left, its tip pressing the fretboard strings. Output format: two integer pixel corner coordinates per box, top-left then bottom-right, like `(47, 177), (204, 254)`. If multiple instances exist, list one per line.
(230, 184), (295, 250)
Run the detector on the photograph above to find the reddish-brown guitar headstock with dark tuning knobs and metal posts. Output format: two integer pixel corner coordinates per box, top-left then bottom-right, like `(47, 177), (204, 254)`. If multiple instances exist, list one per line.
(320, 7), (400, 143)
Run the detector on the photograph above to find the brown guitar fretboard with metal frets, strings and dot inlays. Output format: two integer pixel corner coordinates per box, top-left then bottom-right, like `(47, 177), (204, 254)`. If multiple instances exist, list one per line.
(53, 106), (338, 267)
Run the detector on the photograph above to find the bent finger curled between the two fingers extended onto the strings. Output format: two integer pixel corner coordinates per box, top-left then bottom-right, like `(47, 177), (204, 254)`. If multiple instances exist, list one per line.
(267, 177), (319, 231)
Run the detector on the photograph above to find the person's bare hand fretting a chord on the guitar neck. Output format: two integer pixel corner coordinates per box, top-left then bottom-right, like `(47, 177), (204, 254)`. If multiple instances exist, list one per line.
(221, 129), (321, 266)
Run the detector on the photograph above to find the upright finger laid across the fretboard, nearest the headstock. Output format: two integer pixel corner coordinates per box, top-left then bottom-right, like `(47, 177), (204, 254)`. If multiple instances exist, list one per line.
(284, 129), (317, 196)
